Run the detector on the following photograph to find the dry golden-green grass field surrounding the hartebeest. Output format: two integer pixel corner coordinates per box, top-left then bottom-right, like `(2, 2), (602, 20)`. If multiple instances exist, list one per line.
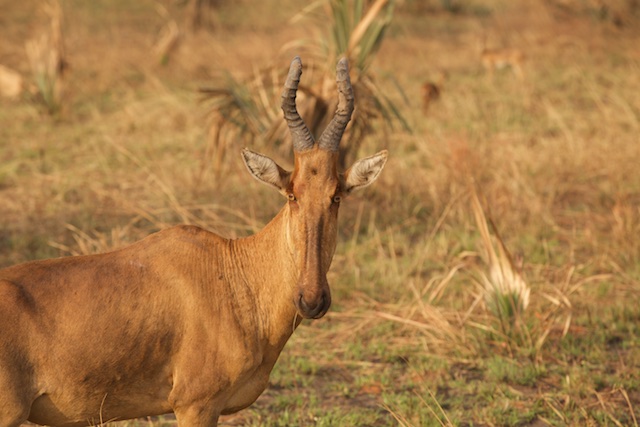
(0, 0), (640, 427)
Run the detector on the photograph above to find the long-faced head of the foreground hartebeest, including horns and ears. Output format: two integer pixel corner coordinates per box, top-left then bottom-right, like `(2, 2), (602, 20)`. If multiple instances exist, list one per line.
(242, 57), (387, 319)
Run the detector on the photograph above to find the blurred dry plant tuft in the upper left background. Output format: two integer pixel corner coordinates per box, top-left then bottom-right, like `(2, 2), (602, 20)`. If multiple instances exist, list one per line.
(25, 0), (66, 115)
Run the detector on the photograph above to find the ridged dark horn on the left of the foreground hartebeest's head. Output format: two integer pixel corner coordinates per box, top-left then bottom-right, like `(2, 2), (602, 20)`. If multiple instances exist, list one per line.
(282, 56), (313, 151)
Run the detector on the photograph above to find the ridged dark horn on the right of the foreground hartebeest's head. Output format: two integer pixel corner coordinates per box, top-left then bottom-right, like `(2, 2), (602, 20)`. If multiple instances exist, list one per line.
(318, 58), (353, 151)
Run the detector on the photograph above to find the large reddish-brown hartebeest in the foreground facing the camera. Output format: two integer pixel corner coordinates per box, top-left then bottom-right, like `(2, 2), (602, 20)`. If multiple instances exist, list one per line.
(0, 57), (387, 427)
